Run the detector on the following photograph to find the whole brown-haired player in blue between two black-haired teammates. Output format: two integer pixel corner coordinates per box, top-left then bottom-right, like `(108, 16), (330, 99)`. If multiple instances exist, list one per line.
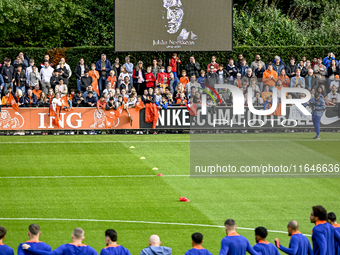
(219, 219), (260, 255)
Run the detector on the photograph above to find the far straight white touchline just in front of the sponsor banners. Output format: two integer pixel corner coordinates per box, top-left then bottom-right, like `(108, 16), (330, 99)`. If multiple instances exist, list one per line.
(0, 139), (340, 144)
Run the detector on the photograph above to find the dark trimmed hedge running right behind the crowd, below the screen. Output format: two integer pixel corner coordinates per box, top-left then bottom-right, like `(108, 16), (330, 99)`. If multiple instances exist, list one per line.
(0, 45), (340, 87)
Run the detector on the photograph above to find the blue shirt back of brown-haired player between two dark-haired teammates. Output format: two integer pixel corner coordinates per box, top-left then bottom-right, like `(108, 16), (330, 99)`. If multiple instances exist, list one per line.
(219, 234), (257, 255)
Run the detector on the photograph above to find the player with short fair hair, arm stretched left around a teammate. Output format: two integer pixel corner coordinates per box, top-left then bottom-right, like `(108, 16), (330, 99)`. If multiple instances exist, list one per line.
(22, 228), (98, 255)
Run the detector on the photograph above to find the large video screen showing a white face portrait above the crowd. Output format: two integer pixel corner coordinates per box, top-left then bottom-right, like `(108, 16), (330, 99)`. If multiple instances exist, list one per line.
(115, 0), (232, 51)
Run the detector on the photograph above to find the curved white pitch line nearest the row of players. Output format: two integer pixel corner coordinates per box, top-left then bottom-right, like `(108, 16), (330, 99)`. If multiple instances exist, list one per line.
(0, 218), (312, 236)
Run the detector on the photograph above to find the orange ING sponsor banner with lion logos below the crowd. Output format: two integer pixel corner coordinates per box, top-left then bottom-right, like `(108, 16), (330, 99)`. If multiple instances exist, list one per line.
(0, 108), (139, 130)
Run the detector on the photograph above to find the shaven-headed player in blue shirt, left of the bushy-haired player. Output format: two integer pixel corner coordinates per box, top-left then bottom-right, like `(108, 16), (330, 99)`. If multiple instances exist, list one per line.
(275, 220), (313, 255)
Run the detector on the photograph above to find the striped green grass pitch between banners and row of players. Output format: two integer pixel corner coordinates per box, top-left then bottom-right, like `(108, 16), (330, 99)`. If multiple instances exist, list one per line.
(0, 133), (340, 255)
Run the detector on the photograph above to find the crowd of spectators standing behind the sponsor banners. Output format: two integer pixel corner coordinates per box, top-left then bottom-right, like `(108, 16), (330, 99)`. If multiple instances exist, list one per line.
(0, 52), (340, 109)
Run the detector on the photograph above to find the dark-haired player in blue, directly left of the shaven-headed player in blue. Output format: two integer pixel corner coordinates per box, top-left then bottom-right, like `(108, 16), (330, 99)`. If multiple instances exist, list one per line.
(254, 227), (280, 255)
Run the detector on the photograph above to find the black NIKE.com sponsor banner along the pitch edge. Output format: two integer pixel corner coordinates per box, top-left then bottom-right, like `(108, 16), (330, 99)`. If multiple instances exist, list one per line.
(140, 106), (340, 129)
